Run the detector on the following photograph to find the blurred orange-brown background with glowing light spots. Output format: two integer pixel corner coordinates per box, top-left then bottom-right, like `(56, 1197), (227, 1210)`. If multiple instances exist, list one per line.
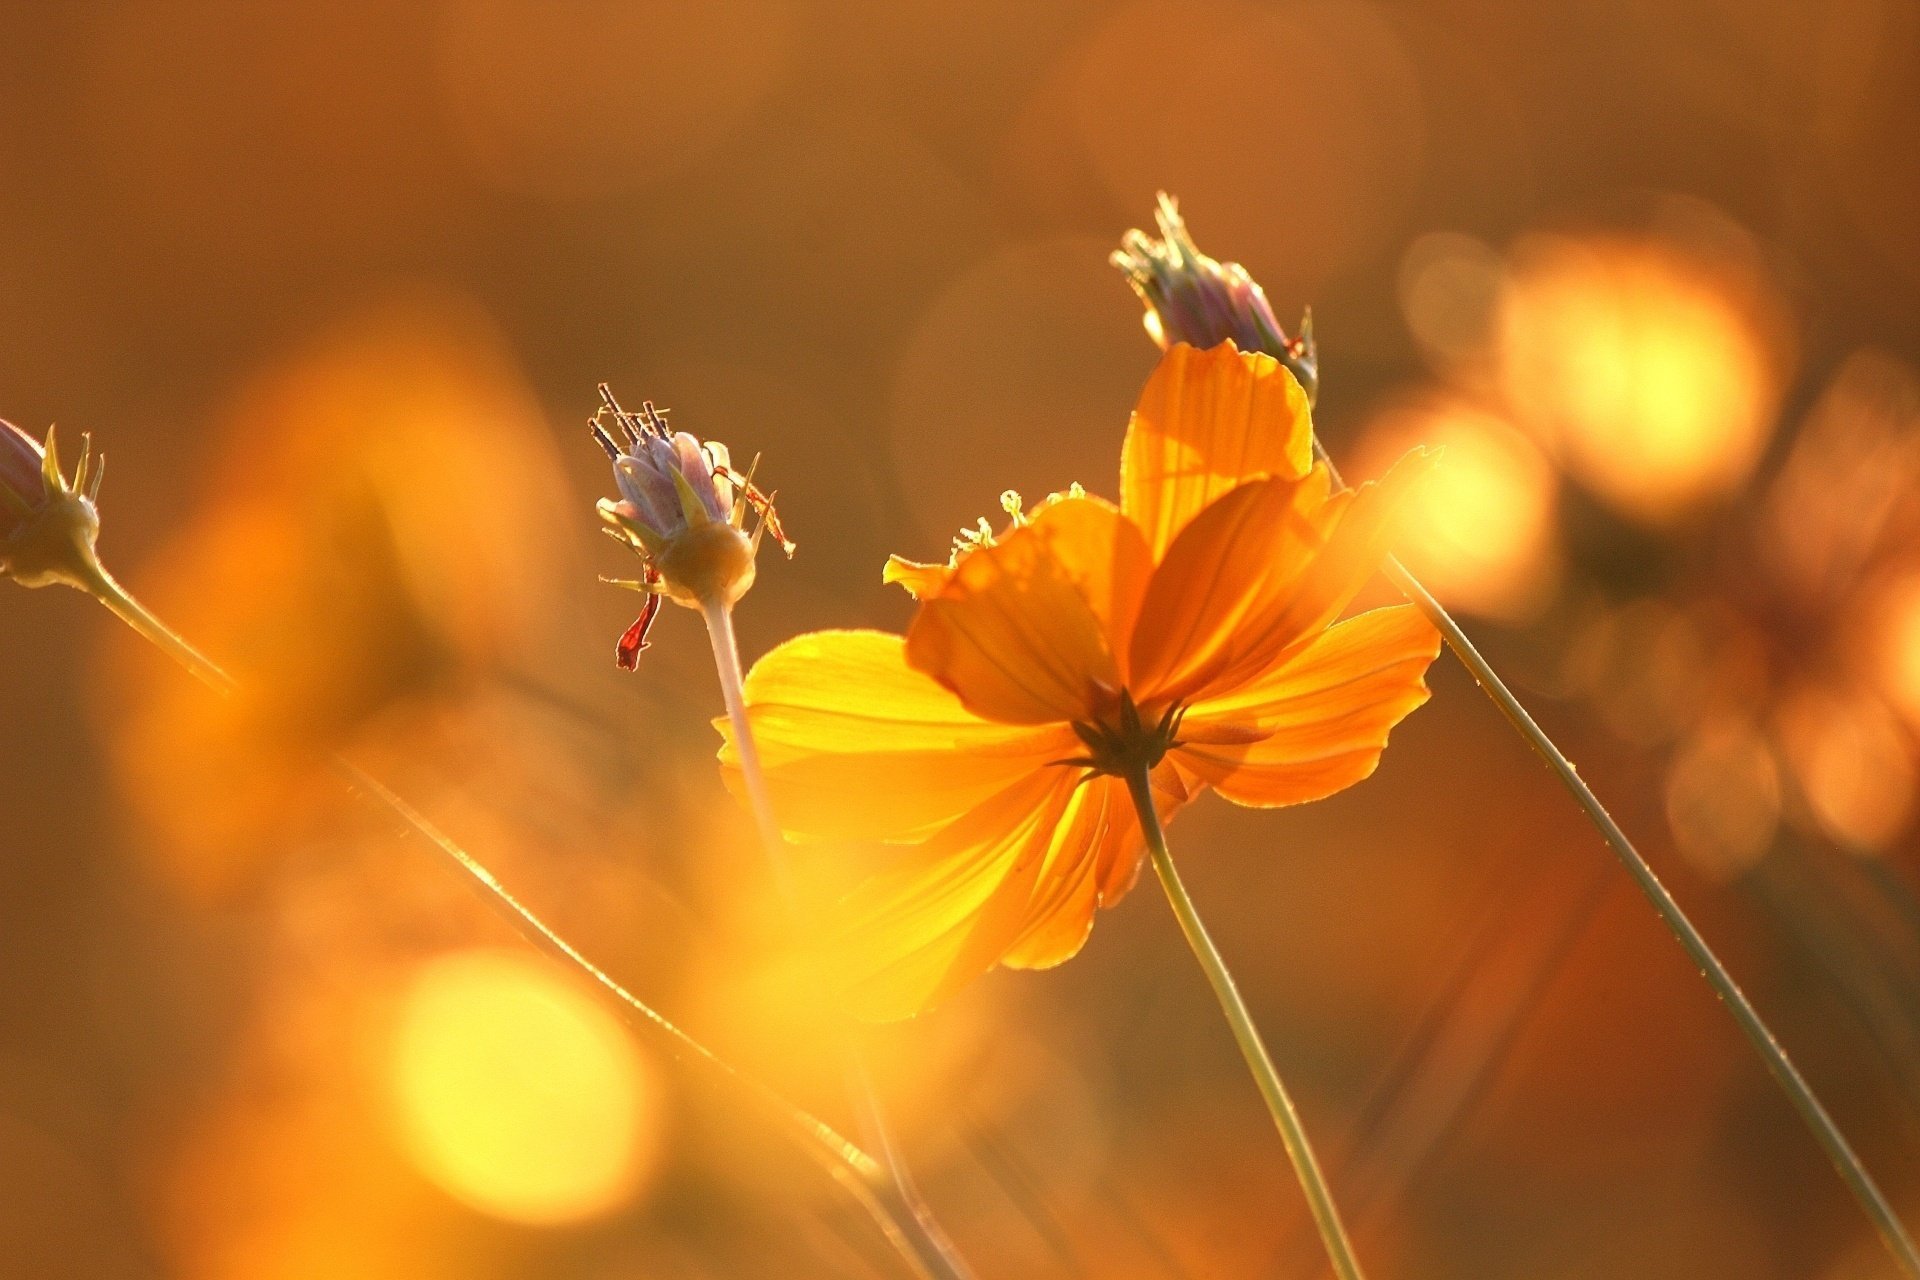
(0, 0), (1920, 1280)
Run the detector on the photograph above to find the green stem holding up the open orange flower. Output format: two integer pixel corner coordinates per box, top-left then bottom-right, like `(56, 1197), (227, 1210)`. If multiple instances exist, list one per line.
(1127, 766), (1361, 1280)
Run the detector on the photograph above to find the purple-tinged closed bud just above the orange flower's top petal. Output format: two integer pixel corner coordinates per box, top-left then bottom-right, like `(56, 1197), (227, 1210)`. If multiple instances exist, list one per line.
(1108, 192), (1319, 401)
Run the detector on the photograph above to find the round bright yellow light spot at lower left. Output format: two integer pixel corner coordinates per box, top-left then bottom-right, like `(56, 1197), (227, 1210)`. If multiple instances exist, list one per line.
(390, 948), (660, 1226)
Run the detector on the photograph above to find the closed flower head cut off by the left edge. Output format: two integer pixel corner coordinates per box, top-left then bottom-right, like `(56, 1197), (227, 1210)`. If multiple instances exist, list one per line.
(0, 420), (108, 587)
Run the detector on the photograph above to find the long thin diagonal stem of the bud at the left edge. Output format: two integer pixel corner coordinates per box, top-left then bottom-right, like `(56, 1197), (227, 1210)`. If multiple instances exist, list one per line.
(63, 562), (925, 1280)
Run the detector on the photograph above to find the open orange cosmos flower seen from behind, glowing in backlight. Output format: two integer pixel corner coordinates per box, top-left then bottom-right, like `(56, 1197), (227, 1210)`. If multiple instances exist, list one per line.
(720, 344), (1440, 1019)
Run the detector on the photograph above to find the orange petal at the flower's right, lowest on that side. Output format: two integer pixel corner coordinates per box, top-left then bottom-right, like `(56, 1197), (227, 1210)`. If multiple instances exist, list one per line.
(1173, 604), (1440, 808)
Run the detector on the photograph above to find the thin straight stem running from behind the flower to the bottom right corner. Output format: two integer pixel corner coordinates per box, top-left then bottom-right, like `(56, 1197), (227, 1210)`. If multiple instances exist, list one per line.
(1313, 439), (1920, 1280)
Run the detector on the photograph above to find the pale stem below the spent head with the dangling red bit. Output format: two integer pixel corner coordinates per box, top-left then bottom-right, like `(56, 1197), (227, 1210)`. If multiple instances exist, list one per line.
(701, 604), (973, 1280)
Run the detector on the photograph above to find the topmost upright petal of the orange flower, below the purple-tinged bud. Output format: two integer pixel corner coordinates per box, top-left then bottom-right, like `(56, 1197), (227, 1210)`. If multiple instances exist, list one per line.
(1119, 342), (1313, 558)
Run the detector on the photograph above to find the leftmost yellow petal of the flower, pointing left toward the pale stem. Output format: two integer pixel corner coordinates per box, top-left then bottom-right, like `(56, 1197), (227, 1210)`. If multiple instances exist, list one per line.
(716, 631), (1079, 841)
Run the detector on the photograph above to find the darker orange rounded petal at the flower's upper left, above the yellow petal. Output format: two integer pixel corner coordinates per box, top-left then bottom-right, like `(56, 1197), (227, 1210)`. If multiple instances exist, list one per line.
(906, 497), (1148, 723)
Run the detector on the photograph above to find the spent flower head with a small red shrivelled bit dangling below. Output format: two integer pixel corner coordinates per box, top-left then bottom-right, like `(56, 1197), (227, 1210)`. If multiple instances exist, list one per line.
(589, 384), (793, 670)
